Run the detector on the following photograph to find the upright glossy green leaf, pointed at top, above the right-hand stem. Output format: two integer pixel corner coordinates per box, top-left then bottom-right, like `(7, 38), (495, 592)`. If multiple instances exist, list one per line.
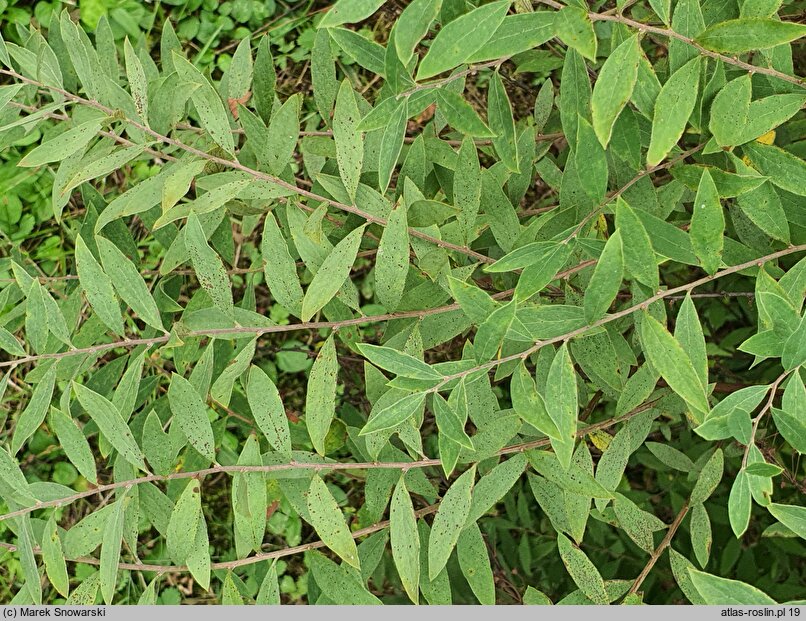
(690, 169), (725, 274)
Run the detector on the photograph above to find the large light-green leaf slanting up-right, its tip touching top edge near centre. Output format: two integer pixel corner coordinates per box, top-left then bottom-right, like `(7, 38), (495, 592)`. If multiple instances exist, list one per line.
(417, 0), (510, 80)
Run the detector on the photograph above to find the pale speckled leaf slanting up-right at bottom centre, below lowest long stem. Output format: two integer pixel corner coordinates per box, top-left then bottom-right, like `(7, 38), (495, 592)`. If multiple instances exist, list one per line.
(428, 466), (476, 580)
